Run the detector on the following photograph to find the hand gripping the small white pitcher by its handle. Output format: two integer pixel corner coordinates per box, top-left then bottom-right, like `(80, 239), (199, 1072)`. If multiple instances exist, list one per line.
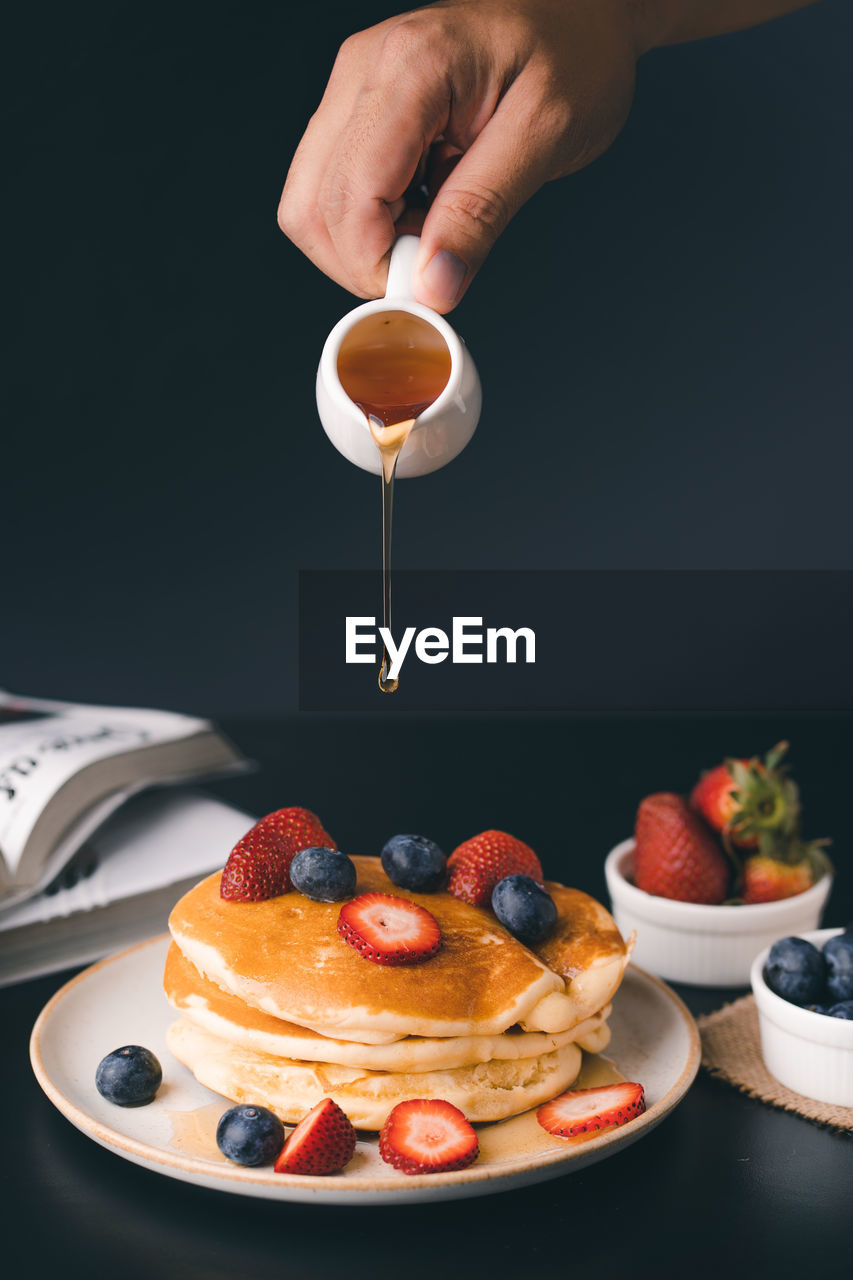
(278, 0), (642, 312)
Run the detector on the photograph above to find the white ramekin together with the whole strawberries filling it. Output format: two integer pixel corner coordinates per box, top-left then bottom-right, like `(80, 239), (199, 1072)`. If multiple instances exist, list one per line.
(605, 742), (833, 987)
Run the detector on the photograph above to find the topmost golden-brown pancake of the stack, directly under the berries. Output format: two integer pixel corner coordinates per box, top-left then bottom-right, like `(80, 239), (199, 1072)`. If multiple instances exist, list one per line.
(169, 858), (628, 1044)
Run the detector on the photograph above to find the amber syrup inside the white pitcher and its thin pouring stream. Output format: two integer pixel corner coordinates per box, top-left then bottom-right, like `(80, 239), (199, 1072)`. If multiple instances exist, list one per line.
(338, 311), (451, 694)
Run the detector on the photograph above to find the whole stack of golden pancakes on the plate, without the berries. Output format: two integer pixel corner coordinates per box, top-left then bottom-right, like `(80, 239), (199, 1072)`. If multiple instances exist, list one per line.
(164, 858), (629, 1129)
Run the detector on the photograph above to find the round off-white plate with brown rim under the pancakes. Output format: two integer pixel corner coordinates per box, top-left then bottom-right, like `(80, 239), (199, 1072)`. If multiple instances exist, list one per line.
(29, 937), (701, 1204)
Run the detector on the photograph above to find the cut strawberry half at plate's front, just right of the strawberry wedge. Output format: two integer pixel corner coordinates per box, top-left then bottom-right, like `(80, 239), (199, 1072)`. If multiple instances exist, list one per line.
(379, 1098), (480, 1174)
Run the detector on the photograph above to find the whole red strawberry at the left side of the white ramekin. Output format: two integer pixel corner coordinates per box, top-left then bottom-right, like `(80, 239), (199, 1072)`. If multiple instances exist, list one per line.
(634, 791), (730, 905)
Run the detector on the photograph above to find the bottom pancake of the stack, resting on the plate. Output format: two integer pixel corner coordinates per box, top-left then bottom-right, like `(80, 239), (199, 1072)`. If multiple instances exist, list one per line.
(167, 1019), (581, 1129)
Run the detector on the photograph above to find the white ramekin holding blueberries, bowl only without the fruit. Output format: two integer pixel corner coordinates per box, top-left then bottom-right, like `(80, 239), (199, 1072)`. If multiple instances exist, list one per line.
(751, 929), (853, 1107)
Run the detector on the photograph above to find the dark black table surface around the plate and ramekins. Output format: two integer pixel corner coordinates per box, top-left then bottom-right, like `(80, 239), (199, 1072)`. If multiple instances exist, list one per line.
(0, 717), (853, 1277)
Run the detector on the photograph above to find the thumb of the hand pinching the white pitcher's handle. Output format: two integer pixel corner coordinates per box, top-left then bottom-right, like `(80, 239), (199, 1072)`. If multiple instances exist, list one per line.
(415, 95), (551, 312)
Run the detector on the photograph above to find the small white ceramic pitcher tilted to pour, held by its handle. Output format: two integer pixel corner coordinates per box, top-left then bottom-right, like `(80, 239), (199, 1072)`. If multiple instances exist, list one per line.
(316, 236), (483, 479)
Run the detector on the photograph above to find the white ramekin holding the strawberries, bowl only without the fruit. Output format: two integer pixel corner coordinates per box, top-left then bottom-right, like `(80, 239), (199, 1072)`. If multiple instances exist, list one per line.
(605, 840), (833, 987)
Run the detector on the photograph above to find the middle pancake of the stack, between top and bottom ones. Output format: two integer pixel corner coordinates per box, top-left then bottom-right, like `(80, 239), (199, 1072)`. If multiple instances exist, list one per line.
(163, 942), (610, 1073)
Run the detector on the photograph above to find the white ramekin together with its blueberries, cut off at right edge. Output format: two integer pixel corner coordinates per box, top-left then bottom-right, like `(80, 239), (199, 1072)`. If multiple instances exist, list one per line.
(751, 924), (853, 1107)
